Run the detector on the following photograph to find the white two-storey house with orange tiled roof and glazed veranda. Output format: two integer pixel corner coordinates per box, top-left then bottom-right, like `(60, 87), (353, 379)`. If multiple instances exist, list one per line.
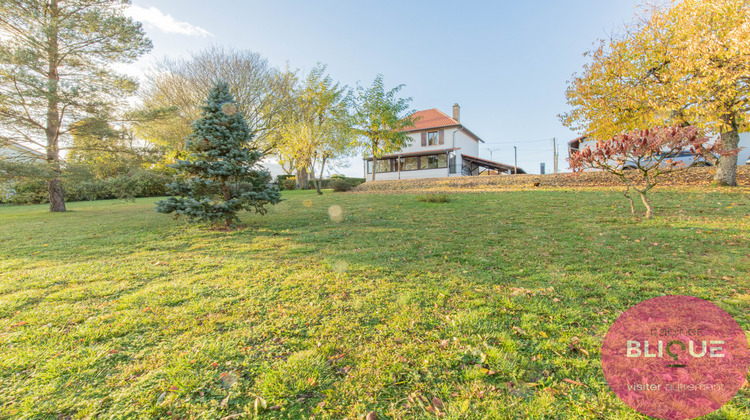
(364, 104), (525, 181)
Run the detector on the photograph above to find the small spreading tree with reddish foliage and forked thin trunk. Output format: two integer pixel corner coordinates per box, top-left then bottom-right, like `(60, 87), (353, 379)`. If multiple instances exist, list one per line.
(568, 126), (739, 219)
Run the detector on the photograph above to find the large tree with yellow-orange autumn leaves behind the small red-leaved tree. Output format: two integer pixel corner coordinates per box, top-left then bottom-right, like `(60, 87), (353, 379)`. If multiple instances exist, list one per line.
(560, 0), (750, 186)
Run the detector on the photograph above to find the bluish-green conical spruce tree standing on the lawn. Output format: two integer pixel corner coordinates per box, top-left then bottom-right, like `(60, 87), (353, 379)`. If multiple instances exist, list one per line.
(156, 82), (281, 227)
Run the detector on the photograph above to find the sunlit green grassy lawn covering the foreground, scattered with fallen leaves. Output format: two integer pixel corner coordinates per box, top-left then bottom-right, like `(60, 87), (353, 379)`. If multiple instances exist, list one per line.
(0, 189), (750, 419)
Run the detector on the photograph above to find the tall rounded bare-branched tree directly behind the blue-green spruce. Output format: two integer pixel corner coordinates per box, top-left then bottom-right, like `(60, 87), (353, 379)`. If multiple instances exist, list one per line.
(136, 47), (296, 157)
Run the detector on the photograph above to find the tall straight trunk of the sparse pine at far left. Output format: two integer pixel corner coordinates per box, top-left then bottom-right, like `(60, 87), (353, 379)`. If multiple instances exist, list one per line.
(45, 0), (66, 212)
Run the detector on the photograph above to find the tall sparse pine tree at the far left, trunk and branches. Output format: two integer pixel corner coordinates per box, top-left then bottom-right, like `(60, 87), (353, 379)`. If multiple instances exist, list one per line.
(0, 0), (151, 212)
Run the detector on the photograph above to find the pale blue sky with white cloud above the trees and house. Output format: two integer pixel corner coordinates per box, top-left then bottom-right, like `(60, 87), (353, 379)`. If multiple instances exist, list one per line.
(127, 0), (638, 177)
